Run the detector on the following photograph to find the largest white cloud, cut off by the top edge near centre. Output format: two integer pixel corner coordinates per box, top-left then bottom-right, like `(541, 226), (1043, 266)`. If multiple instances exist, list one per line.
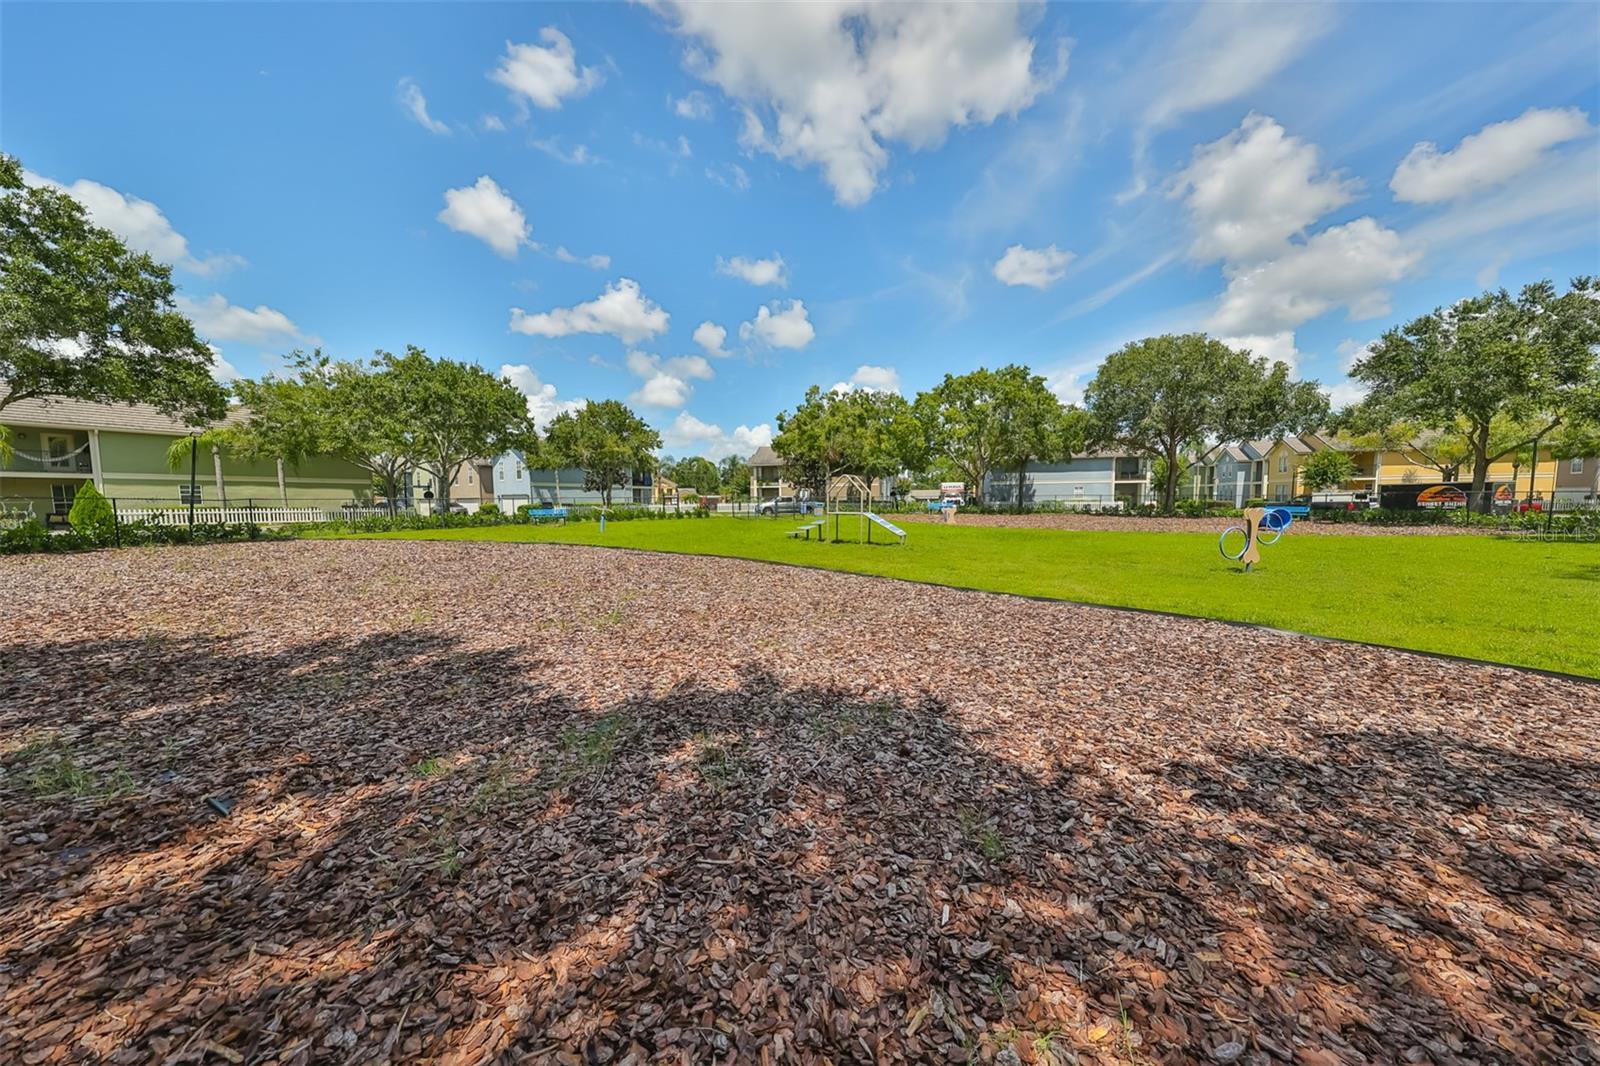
(661, 0), (1048, 205)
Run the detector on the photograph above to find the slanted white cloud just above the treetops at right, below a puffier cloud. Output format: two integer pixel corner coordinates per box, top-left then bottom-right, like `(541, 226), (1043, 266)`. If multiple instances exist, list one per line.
(1211, 218), (1421, 336)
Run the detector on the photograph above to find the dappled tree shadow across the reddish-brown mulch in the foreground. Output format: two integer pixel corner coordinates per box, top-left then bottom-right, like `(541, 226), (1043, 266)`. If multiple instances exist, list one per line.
(0, 631), (1600, 1063)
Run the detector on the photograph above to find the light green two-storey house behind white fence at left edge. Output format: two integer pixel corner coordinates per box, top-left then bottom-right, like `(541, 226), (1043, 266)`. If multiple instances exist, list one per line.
(0, 386), (371, 522)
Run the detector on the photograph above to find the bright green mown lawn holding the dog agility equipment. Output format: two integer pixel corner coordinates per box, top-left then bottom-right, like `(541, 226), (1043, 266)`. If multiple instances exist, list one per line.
(347, 519), (1600, 677)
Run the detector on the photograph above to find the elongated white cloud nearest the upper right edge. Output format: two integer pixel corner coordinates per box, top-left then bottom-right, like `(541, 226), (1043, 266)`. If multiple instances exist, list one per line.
(1389, 107), (1592, 203)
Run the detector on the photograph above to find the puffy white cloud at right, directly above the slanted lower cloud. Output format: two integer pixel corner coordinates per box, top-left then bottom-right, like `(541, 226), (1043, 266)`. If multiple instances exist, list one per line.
(1171, 114), (1358, 264)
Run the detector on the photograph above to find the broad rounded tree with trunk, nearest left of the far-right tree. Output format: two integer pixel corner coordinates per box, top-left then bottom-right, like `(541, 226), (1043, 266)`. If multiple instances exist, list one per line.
(1083, 333), (1328, 511)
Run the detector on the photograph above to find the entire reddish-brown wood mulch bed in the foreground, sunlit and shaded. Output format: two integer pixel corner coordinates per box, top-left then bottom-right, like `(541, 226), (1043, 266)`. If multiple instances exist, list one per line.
(0, 541), (1600, 1066)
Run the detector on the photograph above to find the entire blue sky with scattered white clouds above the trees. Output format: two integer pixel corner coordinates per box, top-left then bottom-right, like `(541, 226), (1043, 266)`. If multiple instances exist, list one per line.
(0, 2), (1600, 458)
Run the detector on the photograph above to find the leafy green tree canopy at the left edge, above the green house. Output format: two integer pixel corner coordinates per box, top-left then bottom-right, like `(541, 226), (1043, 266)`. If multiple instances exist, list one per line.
(0, 155), (227, 448)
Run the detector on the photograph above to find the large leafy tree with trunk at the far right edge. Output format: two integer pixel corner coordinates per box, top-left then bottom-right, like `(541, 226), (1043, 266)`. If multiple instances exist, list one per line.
(1349, 277), (1600, 507)
